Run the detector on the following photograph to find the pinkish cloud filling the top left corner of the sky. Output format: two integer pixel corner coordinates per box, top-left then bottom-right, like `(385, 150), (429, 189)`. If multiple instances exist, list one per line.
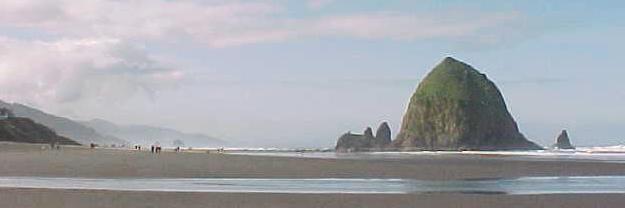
(0, 0), (279, 45)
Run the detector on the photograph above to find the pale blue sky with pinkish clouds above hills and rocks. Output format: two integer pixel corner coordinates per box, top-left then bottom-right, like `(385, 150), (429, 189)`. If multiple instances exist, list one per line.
(0, 0), (625, 147)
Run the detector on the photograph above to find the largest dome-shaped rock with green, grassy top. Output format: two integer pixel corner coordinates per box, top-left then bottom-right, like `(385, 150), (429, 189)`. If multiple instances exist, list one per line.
(393, 57), (542, 150)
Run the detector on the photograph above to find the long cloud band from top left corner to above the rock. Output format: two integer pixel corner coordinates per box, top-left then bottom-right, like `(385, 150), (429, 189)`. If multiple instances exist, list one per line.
(0, 0), (520, 47)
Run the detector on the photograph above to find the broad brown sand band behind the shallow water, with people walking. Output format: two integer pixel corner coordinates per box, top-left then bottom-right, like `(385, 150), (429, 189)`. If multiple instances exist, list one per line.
(0, 141), (625, 180)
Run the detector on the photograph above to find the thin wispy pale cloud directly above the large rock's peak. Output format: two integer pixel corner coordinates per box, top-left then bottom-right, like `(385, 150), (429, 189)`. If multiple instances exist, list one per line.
(310, 12), (519, 40)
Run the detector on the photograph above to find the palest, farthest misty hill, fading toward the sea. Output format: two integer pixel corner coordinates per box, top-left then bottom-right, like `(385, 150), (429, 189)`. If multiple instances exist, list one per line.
(81, 119), (226, 147)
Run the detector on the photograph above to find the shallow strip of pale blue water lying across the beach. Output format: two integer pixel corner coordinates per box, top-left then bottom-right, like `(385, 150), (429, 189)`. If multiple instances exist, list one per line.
(0, 176), (625, 195)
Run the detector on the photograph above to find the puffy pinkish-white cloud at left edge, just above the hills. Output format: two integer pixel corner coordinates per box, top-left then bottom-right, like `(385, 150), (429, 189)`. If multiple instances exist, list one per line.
(0, 37), (182, 104)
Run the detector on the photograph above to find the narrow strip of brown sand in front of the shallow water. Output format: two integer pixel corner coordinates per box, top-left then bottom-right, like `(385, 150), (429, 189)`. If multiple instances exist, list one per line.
(0, 188), (625, 208)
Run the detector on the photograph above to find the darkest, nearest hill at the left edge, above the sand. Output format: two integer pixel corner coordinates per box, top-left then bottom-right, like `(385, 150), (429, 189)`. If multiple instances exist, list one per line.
(0, 117), (80, 145)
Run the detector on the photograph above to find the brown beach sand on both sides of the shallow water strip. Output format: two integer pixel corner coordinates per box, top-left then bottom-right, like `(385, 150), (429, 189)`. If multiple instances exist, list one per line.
(0, 144), (625, 207)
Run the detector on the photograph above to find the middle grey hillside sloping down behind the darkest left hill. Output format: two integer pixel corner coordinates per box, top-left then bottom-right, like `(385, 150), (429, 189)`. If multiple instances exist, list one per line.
(0, 100), (128, 144)
